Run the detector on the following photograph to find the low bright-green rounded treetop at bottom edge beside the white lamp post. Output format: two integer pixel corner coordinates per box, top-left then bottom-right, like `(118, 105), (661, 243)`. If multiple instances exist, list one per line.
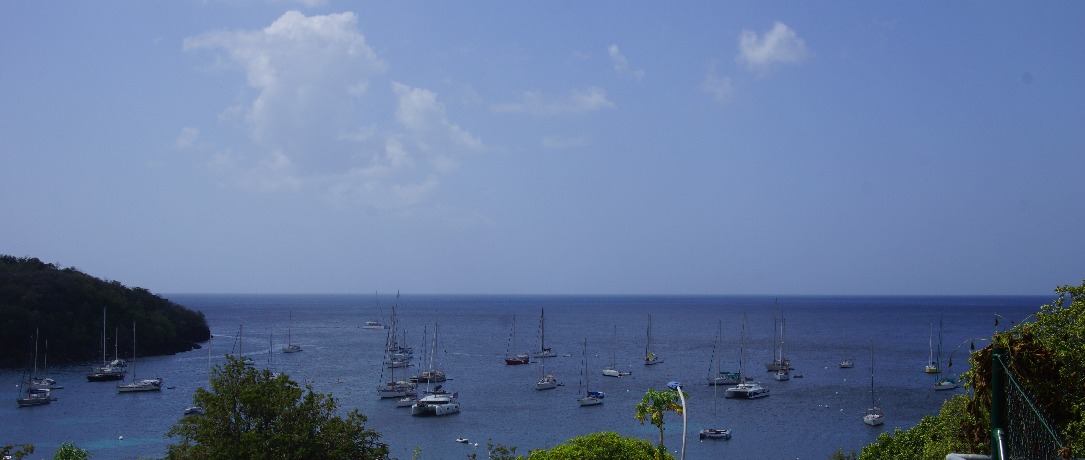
(527, 432), (674, 460)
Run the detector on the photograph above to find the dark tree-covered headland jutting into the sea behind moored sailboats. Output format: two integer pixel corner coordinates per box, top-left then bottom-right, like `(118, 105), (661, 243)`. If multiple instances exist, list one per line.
(0, 255), (210, 366)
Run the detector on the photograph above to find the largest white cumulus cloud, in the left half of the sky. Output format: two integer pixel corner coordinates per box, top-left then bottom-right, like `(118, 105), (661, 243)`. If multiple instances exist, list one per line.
(184, 11), (484, 209)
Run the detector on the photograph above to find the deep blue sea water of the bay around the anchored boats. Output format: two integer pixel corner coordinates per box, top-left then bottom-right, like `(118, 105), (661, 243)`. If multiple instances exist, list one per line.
(0, 294), (1052, 459)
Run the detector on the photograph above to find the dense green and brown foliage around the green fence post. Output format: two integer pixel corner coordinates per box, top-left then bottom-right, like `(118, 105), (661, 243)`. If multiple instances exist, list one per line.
(859, 282), (1085, 459)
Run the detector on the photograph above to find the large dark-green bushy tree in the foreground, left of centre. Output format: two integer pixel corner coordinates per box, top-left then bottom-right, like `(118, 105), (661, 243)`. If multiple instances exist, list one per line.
(167, 356), (388, 459)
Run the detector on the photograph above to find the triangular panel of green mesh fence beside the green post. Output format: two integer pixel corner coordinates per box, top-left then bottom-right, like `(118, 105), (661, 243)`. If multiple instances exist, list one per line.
(995, 353), (1063, 460)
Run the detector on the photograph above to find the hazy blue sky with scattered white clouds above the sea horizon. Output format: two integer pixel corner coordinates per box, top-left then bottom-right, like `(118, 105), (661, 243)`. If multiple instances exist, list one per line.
(0, 0), (1085, 294)
